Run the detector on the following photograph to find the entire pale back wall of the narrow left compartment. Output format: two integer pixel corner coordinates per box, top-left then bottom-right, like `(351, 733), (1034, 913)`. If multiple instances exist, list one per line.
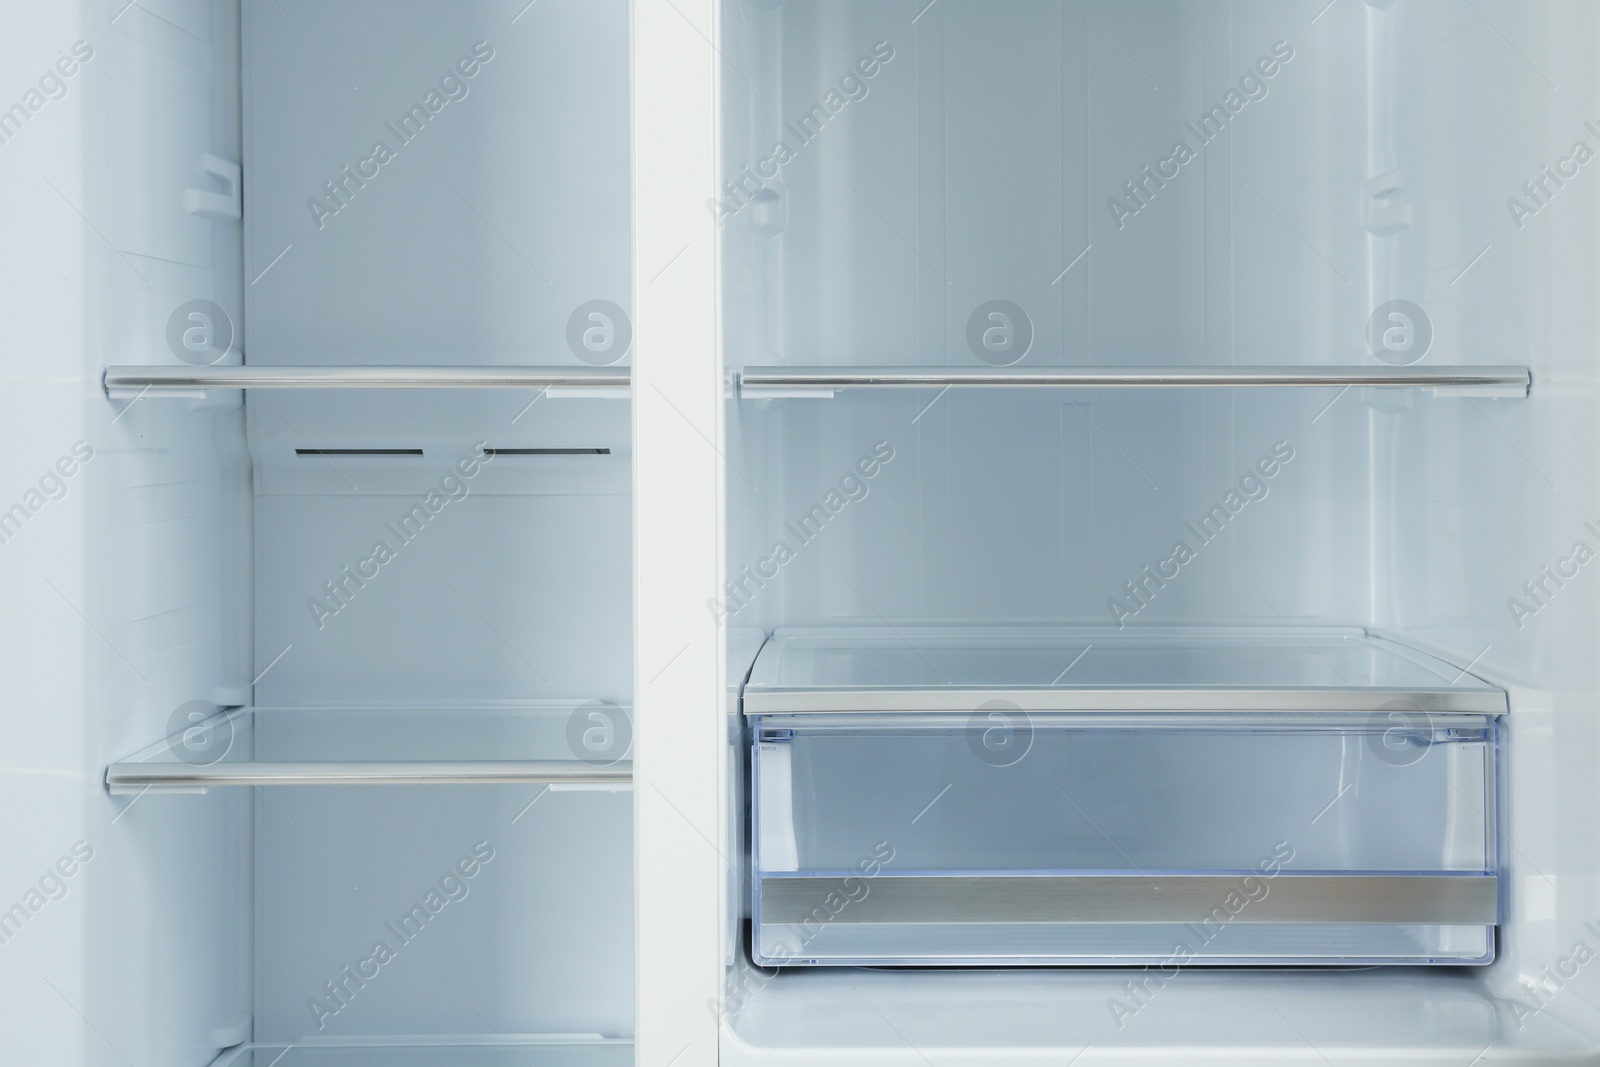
(245, 0), (634, 1040)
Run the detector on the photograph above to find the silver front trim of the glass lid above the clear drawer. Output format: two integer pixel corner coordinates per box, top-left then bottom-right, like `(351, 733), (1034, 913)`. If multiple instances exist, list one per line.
(744, 686), (1509, 715)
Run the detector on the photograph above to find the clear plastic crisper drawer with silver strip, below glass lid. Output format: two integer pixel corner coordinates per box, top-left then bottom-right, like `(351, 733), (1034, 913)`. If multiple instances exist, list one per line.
(750, 713), (1499, 966)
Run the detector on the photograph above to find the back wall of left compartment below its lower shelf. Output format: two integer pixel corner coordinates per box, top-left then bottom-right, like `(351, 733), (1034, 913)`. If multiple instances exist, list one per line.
(256, 785), (634, 1041)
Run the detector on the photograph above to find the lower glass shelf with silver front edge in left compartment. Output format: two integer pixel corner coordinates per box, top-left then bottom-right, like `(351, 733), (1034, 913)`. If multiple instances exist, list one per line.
(106, 701), (634, 793)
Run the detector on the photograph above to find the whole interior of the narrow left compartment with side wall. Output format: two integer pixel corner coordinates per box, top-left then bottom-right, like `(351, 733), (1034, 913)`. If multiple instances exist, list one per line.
(0, 0), (634, 1067)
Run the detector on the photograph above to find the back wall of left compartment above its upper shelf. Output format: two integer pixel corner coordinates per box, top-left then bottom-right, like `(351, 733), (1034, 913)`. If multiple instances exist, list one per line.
(246, 0), (630, 365)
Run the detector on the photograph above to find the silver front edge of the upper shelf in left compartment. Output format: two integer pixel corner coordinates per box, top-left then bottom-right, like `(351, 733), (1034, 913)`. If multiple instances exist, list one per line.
(104, 366), (632, 398)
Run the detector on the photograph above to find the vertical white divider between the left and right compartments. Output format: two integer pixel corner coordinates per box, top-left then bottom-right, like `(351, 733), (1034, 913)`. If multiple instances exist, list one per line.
(632, 0), (725, 1067)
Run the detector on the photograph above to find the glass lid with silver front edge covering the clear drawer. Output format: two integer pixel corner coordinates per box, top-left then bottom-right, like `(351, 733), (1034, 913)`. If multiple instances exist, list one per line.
(744, 625), (1507, 715)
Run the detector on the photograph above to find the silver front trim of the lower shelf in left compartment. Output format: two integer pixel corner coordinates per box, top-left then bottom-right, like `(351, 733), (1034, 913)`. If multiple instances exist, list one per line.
(106, 760), (634, 790)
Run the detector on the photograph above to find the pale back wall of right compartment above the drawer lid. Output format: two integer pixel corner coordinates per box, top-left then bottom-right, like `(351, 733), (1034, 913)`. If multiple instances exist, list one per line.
(725, 3), (1376, 625)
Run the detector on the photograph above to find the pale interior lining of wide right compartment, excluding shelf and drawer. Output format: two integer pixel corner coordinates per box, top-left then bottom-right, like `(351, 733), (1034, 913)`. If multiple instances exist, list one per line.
(723, 0), (1600, 1064)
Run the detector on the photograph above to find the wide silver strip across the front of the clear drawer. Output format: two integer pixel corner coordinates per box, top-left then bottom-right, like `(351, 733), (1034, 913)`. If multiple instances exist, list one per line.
(760, 872), (1499, 926)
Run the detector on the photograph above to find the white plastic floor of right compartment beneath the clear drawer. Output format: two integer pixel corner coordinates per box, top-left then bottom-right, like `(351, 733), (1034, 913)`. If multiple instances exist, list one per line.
(720, 968), (1600, 1067)
